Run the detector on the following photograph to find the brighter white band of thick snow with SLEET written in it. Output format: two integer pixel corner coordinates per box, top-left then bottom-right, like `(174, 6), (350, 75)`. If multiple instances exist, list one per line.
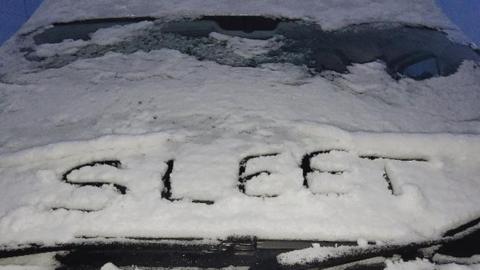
(0, 125), (480, 244)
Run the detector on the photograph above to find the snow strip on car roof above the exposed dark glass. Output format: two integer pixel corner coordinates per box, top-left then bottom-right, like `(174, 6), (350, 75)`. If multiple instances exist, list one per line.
(28, 0), (454, 30)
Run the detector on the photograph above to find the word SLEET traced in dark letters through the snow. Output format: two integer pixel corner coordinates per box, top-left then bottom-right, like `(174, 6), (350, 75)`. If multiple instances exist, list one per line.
(62, 146), (428, 204)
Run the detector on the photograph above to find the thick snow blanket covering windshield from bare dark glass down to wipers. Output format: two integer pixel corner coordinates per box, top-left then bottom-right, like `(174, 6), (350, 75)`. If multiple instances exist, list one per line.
(0, 11), (480, 249)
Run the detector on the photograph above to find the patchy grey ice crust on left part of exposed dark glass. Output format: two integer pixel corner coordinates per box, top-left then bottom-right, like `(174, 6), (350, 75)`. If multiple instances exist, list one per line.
(27, 19), (288, 68)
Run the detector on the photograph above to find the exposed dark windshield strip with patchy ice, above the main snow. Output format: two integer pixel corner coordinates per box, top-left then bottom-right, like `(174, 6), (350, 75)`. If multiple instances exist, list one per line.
(26, 16), (480, 80)
